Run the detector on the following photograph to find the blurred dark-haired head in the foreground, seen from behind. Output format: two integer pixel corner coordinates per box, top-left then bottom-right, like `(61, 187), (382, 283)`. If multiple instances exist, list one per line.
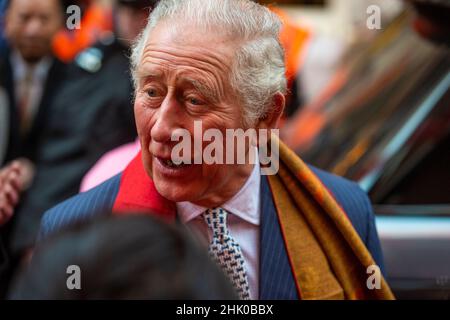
(9, 215), (236, 299)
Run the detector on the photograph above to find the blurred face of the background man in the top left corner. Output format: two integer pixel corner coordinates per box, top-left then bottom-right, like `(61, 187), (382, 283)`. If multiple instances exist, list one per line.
(5, 0), (62, 63)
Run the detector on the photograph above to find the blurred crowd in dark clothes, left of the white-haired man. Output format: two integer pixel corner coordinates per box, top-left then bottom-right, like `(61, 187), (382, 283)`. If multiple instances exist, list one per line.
(0, 0), (156, 296)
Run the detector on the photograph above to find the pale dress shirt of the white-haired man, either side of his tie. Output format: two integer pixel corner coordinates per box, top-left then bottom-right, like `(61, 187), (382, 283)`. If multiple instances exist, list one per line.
(177, 151), (261, 300)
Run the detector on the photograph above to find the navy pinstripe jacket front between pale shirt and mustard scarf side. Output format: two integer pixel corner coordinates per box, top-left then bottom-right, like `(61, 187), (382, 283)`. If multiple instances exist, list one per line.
(259, 176), (299, 300)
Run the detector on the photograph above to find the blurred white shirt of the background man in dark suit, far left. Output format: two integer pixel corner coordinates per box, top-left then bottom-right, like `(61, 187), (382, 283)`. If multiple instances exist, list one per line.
(11, 51), (51, 130)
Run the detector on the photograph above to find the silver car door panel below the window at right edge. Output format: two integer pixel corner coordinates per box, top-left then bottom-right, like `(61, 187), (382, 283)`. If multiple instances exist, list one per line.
(375, 204), (450, 300)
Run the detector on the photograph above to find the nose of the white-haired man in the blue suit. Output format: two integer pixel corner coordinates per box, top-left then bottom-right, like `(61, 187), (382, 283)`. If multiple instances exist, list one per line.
(150, 95), (180, 143)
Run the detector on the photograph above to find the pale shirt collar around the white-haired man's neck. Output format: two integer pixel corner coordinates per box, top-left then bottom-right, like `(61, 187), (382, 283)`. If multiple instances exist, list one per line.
(176, 150), (261, 225)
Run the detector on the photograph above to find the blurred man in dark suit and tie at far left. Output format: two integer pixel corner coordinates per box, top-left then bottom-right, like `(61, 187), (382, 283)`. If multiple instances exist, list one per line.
(0, 0), (65, 164)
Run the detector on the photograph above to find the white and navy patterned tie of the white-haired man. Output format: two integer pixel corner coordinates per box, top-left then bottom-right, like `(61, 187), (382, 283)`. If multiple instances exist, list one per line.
(203, 208), (250, 300)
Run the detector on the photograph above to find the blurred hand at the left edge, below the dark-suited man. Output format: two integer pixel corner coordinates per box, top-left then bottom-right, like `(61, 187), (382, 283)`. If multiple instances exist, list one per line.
(0, 159), (34, 226)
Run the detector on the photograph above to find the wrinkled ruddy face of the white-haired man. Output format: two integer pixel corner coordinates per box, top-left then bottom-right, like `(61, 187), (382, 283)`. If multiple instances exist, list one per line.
(135, 23), (253, 207)
